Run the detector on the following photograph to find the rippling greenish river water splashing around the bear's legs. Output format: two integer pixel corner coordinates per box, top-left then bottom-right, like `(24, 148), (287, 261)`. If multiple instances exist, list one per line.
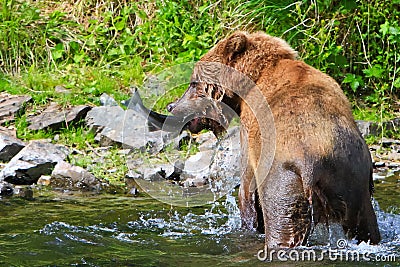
(0, 175), (400, 266)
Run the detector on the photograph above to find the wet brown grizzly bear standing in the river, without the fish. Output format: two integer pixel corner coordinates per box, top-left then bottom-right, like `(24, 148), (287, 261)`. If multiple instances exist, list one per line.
(167, 32), (380, 247)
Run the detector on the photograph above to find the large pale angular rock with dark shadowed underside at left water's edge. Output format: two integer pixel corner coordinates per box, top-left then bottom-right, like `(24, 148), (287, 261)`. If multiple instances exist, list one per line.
(0, 140), (69, 185)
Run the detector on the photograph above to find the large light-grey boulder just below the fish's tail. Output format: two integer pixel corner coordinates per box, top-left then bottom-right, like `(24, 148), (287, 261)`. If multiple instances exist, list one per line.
(86, 106), (172, 153)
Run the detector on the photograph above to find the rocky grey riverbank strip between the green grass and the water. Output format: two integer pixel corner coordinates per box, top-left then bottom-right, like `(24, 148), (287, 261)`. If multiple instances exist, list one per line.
(0, 93), (400, 198)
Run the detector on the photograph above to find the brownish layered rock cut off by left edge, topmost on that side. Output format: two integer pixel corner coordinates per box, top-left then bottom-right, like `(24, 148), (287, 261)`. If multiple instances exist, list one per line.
(0, 92), (32, 124)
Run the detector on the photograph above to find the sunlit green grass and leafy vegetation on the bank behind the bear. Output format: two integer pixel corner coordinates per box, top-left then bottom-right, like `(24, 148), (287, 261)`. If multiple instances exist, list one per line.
(0, 0), (400, 184)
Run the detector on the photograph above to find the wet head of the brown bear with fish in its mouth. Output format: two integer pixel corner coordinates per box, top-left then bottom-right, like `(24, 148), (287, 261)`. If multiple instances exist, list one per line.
(167, 31), (297, 136)
